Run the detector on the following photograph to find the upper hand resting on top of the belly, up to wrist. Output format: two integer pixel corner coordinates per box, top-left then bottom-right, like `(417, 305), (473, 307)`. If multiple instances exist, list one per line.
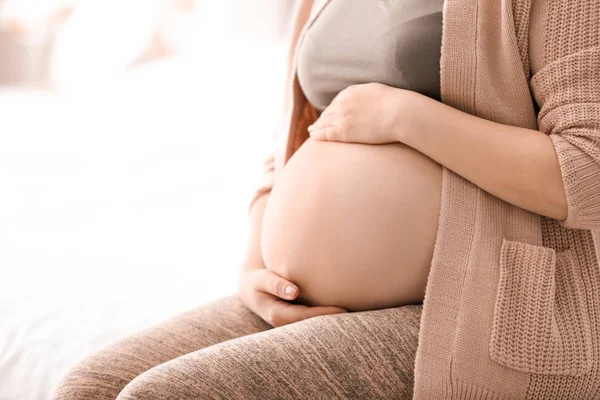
(308, 83), (415, 144)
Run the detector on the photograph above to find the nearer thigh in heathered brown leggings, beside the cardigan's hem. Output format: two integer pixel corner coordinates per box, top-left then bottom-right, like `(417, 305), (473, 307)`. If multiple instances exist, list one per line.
(118, 304), (423, 400)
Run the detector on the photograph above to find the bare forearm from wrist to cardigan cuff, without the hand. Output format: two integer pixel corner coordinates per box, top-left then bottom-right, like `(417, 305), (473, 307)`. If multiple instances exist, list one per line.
(397, 92), (567, 220)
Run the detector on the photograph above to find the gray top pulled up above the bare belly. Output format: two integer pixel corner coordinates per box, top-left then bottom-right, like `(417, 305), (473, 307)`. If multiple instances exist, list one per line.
(298, 0), (444, 111)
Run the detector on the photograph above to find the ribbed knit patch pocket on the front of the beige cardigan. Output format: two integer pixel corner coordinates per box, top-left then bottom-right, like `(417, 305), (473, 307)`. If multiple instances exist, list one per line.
(489, 238), (592, 376)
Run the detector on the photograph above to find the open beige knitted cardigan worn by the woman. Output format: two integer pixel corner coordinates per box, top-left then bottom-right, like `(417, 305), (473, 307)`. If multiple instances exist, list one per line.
(250, 0), (600, 400)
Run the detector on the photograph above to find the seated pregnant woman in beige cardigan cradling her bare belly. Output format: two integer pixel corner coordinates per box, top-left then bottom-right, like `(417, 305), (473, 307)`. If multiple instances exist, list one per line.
(55, 0), (600, 400)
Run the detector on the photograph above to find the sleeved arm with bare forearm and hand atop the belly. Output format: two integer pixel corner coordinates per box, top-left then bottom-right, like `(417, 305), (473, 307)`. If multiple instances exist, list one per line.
(308, 0), (600, 230)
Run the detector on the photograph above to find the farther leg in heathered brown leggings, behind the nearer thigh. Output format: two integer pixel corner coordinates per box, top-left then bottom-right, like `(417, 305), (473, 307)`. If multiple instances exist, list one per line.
(54, 295), (273, 400)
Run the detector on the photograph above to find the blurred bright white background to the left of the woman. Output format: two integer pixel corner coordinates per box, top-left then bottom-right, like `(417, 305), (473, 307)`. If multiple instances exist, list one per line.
(0, 0), (295, 400)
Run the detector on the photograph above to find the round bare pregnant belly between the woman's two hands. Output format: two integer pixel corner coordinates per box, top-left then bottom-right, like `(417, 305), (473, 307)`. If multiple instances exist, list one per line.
(262, 139), (442, 311)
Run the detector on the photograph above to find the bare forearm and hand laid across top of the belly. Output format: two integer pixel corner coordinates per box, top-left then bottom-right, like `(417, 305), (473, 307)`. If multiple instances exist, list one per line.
(309, 83), (568, 221)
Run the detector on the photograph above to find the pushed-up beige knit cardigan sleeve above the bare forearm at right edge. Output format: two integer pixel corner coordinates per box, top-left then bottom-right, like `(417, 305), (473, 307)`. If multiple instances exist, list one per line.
(530, 9), (600, 230)
